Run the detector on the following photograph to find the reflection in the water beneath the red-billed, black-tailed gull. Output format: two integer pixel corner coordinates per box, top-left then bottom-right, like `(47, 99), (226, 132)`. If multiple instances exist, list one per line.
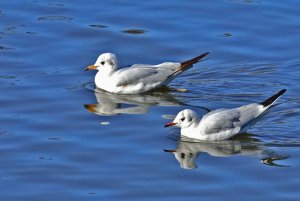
(164, 134), (288, 169)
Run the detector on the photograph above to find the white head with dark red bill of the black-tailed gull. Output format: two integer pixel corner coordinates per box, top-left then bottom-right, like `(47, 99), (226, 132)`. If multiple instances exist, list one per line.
(165, 109), (198, 128)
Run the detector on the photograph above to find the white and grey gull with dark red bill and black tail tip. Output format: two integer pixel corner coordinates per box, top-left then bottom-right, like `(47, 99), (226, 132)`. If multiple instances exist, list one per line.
(165, 89), (286, 141)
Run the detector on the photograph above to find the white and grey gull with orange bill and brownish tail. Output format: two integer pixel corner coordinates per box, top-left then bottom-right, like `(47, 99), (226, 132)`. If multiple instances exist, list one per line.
(85, 52), (209, 94)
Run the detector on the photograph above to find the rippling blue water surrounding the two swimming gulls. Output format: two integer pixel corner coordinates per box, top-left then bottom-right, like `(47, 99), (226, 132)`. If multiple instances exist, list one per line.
(0, 0), (300, 201)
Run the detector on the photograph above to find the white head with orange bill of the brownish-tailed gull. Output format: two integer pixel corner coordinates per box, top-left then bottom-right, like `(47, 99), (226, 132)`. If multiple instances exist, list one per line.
(85, 53), (118, 71)
